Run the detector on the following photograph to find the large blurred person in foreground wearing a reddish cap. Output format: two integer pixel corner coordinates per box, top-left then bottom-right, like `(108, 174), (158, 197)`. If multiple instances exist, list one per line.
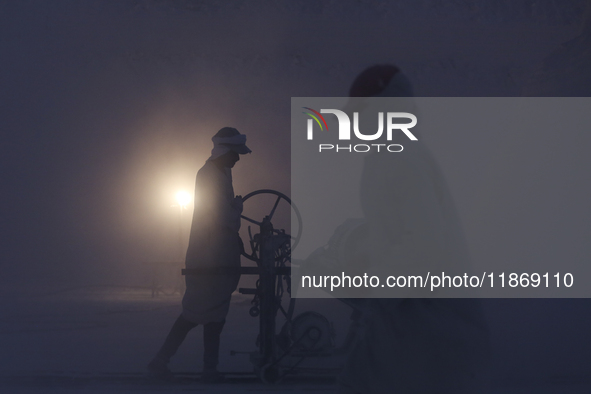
(328, 65), (490, 394)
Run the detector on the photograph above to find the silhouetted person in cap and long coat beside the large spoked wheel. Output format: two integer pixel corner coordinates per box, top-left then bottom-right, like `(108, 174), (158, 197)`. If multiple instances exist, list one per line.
(148, 127), (251, 382)
